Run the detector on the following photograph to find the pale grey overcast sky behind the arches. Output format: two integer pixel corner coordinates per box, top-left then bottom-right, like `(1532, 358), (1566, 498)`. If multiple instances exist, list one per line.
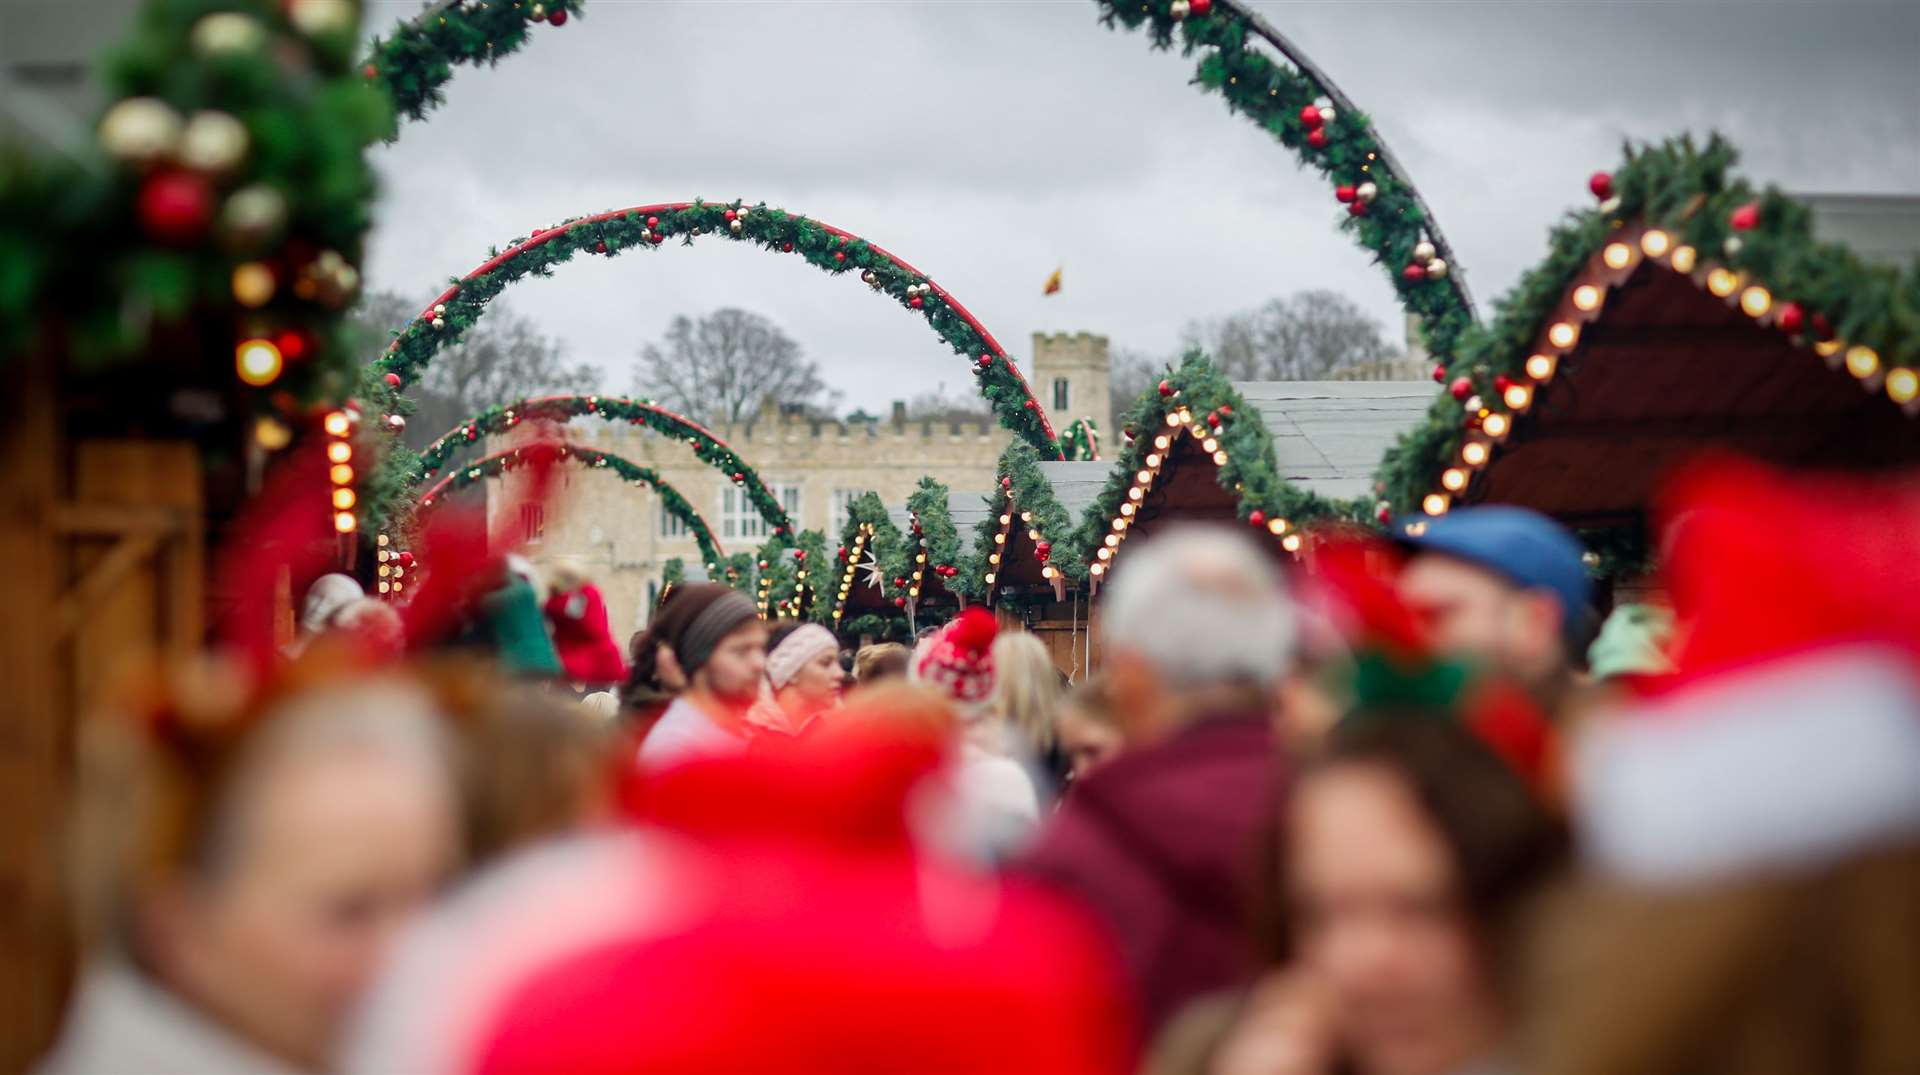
(369, 0), (1920, 409)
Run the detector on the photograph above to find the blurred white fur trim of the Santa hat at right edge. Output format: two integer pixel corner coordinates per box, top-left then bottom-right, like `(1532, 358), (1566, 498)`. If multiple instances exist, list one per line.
(1574, 643), (1920, 885)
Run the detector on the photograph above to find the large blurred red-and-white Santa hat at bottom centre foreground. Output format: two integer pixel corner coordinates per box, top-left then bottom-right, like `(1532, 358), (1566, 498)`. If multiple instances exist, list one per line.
(348, 716), (1133, 1075)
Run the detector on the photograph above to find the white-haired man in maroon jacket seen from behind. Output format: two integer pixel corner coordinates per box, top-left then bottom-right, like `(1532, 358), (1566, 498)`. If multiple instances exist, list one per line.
(1016, 528), (1294, 1040)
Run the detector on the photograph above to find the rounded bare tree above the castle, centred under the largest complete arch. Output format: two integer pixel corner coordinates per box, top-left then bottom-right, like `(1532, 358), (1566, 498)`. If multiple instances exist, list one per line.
(634, 307), (839, 422)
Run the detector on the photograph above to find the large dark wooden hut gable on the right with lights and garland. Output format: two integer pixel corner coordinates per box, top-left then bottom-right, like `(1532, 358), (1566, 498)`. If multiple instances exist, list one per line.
(1382, 142), (1920, 576)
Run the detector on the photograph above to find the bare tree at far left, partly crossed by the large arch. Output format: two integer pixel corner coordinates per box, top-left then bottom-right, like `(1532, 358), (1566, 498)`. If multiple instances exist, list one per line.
(353, 292), (601, 447)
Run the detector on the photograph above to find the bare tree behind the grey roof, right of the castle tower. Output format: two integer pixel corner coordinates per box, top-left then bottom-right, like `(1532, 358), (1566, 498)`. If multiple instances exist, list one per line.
(1181, 290), (1392, 380)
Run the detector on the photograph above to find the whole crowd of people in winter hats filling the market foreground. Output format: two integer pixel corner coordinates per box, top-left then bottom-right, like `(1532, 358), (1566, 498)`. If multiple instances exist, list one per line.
(30, 454), (1920, 1075)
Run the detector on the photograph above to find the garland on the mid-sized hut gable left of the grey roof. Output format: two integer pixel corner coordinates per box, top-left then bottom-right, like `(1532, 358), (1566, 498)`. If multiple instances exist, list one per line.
(1054, 351), (1365, 578)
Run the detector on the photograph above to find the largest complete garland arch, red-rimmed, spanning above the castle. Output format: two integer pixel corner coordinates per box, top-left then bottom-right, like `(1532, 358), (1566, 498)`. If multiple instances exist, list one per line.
(361, 202), (1060, 459)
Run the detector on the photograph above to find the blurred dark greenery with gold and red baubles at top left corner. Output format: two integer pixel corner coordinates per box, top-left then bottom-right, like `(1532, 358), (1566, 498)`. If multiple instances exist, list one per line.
(0, 0), (392, 401)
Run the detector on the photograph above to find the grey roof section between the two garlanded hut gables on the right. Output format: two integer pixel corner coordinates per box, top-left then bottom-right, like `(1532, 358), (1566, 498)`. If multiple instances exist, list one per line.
(1233, 380), (1436, 499)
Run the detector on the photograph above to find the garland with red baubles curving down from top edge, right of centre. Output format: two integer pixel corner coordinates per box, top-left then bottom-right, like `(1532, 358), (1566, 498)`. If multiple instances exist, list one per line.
(1098, 0), (1473, 365)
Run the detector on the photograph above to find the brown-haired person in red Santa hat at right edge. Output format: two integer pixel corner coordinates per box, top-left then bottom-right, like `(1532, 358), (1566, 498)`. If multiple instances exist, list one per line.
(1532, 463), (1920, 1075)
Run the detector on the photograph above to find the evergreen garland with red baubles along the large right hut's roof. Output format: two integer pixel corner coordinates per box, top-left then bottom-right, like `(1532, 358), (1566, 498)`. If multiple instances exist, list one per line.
(1377, 134), (1920, 513)
